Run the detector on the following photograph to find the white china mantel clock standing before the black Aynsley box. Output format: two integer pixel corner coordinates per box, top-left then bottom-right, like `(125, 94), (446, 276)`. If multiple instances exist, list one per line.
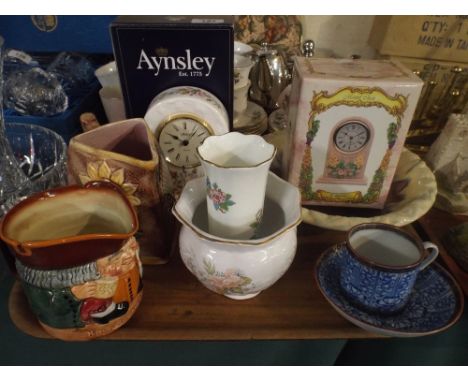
(145, 86), (229, 196)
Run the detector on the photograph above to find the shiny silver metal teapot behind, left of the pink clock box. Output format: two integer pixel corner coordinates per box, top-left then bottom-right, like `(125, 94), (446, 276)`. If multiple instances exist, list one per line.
(249, 42), (291, 114)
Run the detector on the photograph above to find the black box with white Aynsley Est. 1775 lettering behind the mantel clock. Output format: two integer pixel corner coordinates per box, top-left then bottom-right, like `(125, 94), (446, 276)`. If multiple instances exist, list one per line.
(111, 16), (234, 120)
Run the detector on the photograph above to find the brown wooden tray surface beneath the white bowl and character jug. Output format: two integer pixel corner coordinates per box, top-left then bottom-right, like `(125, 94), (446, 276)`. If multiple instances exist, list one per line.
(9, 224), (392, 340)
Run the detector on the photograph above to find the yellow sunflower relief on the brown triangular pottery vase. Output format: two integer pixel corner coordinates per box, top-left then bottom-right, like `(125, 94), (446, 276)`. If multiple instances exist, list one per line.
(80, 161), (141, 206)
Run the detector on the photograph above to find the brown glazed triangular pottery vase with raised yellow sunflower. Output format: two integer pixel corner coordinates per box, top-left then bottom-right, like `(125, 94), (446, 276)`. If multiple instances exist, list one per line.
(68, 118), (174, 264)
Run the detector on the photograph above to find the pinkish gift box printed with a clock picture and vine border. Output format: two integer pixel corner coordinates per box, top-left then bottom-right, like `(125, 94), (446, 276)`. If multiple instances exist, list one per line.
(284, 57), (423, 208)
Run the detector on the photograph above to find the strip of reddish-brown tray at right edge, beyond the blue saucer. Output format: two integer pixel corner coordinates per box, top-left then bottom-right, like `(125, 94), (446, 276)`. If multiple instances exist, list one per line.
(417, 208), (468, 296)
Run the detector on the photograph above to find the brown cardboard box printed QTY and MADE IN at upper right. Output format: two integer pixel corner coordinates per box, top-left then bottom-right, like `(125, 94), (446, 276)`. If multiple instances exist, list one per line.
(369, 16), (468, 63)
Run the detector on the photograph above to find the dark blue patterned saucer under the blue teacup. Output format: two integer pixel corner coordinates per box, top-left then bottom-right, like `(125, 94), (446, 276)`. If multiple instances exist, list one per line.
(315, 243), (464, 337)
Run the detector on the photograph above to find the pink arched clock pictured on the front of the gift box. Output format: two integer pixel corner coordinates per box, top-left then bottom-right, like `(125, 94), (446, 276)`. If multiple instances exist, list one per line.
(317, 117), (374, 185)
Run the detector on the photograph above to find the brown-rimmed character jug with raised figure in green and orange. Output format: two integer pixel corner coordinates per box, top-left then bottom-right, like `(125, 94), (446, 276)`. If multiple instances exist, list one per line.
(0, 181), (142, 340)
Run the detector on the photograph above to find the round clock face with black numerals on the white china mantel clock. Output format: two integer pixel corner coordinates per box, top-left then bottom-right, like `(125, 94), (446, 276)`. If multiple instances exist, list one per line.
(159, 117), (211, 168)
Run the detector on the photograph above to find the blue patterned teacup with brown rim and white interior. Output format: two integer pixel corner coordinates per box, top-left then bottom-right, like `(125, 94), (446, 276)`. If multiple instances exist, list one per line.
(340, 223), (439, 314)
